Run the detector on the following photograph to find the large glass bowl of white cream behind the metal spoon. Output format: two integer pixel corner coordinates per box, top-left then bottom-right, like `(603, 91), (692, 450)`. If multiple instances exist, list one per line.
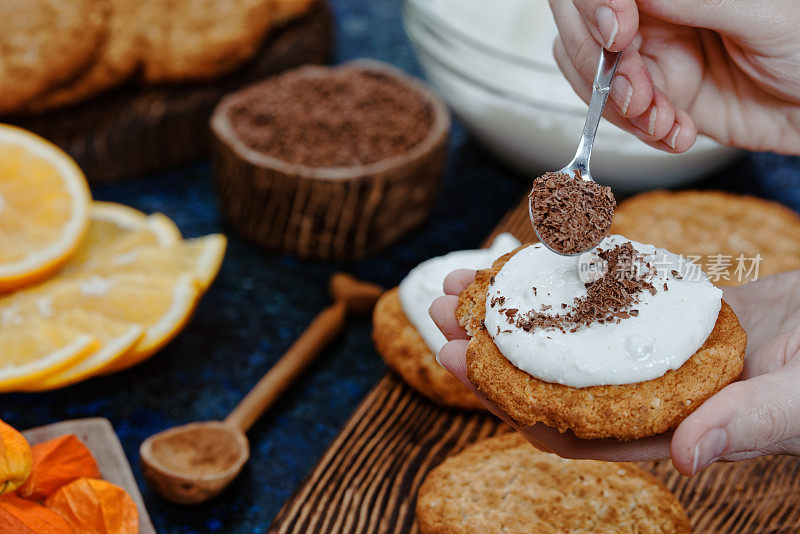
(403, 0), (738, 192)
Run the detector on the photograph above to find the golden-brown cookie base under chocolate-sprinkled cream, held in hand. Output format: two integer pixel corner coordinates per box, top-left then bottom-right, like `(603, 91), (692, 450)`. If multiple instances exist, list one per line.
(456, 253), (747, 440)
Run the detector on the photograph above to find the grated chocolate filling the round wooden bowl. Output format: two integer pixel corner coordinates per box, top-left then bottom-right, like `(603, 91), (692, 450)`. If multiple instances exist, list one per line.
(229, 68), (434, 167)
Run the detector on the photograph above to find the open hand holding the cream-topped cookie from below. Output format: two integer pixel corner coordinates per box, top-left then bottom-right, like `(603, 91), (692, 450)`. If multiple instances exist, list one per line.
(430, 270), (800, 475)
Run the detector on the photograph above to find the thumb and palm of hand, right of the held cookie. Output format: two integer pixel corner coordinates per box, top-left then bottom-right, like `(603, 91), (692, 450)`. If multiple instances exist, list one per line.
(671, 270), (800, 474)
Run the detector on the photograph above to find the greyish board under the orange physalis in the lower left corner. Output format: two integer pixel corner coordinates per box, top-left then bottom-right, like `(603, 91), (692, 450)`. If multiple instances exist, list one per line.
(22, 417), (156, 534)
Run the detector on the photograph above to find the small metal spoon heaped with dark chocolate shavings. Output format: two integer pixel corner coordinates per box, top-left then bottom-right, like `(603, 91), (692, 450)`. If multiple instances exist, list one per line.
(529, 48), (621, 256)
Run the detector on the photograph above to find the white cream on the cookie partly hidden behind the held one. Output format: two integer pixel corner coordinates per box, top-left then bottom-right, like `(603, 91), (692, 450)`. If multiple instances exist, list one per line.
(399, 234), (520, 354)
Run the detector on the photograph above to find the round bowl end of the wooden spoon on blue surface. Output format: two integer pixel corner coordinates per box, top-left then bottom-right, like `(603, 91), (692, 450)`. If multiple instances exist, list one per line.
(140, 421), (250, 504)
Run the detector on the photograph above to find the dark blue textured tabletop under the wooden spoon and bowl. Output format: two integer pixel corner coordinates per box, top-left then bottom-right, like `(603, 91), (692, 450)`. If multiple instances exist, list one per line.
(0, 0), (800, 533)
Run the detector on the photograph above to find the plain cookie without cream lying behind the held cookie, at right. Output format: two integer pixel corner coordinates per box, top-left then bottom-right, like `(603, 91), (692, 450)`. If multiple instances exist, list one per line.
(611, 191), (800, 285)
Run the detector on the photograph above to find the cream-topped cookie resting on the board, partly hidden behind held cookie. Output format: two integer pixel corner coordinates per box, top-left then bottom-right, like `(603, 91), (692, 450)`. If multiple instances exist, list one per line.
(372, 234), (519, 410)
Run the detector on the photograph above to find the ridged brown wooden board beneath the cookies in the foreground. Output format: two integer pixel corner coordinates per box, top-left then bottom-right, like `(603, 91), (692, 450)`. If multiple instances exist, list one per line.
(268, 198), (800, 534)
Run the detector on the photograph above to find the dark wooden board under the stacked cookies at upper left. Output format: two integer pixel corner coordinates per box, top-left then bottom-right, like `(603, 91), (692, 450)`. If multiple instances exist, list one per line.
(2, 0), (333, 183)
